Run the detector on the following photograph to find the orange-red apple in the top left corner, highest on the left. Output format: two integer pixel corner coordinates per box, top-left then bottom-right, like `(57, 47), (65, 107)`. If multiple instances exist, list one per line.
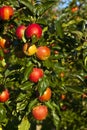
(0, 6), (14, 20)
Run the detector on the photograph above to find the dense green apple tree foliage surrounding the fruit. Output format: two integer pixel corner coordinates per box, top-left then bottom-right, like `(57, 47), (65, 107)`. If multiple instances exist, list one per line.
(0, 0), (87, 130)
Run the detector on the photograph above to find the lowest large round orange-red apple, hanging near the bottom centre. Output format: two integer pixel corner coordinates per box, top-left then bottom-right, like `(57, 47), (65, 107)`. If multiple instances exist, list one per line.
(32, 105), (48, 121)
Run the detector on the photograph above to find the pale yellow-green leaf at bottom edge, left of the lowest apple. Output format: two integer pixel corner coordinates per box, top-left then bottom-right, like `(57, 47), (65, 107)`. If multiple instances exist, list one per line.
(18, 117), (30, 130)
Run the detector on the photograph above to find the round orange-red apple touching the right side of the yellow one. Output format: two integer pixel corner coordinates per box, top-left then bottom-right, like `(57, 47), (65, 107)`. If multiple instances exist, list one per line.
(36, 46), (51, 60)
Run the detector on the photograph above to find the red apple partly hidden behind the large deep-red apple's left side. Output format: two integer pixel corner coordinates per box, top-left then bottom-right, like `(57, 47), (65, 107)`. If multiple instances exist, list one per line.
(16, 25), (26, 39)
